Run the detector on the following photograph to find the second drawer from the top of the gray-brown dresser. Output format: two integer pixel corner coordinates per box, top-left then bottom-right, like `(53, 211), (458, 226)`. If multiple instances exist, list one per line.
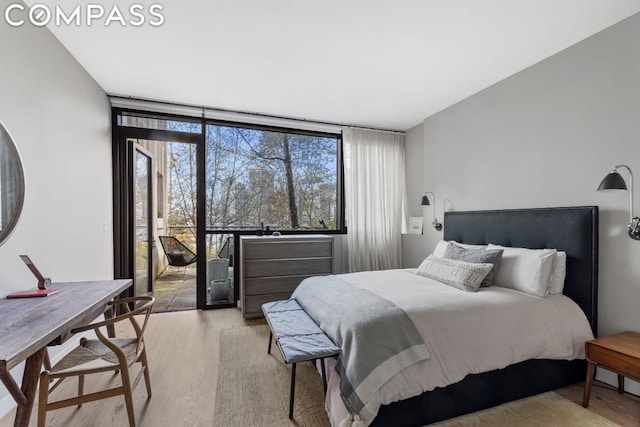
(244, 258), (331, 280)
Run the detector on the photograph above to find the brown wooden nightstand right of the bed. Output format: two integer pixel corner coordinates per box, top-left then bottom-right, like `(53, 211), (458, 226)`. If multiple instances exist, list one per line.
(582, 331), (640, 408)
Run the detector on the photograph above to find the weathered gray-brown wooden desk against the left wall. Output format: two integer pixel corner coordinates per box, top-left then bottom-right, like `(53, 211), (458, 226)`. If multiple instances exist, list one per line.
(0, 279), (132, 427)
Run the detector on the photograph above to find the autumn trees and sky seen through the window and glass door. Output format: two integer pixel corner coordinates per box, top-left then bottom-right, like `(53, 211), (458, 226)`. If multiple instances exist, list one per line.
(167, 125), (338, 234)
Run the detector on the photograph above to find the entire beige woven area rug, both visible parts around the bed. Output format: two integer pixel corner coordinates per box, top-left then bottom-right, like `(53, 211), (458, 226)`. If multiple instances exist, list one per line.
(214, 325), (617, 427)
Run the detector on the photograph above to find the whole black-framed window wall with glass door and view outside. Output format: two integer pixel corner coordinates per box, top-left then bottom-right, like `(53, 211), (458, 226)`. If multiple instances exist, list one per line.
(114, 109), (345, 309)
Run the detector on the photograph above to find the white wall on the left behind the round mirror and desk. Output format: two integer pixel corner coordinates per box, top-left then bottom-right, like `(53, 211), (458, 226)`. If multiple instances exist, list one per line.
(0, 4), (113, 416)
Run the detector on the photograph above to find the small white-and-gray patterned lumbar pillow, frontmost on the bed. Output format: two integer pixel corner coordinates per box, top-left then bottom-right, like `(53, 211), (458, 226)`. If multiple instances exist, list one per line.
(416, 255), (493, 292)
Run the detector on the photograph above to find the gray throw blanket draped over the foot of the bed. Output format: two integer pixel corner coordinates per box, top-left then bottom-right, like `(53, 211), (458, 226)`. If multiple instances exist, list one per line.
(292, 276), (430, 414)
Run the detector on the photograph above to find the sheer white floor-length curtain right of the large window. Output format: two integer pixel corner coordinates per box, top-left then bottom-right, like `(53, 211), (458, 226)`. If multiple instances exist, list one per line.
(342, 128), (405, 272)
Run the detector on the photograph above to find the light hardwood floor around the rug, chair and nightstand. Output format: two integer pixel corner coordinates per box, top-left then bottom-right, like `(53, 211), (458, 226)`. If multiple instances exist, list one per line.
(0, 309), (640, 427)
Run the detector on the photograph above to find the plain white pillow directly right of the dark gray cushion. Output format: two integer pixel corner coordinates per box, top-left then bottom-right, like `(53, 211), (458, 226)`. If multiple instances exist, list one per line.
(489, 244), (558, 297)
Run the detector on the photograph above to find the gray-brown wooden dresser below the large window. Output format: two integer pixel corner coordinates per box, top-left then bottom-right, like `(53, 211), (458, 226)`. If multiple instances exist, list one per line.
(240, 234), (334, 319)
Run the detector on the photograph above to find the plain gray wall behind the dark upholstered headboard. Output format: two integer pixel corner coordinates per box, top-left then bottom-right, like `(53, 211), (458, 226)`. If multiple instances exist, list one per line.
(407, 14), (640, 393)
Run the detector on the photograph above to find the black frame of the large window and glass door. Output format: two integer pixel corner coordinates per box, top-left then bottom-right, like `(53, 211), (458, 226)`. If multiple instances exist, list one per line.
(111, 106), (347, 309)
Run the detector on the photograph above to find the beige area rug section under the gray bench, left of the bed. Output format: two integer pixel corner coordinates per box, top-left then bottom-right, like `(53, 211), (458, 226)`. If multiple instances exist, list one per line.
(214, 325), (329, 427)
